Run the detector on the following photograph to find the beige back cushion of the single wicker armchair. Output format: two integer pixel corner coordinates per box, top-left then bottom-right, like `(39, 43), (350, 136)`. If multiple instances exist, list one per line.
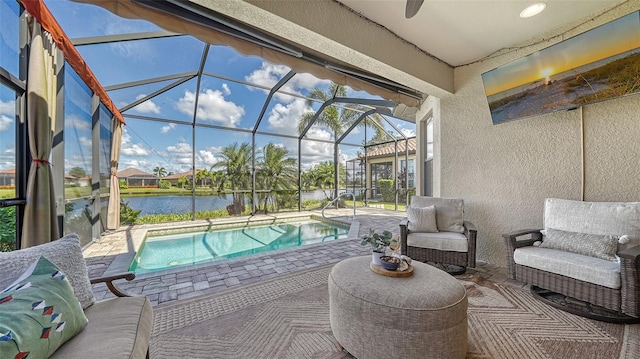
(410, 196), (464, 233)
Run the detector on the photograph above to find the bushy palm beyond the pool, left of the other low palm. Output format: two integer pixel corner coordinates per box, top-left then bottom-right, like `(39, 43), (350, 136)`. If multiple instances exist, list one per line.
(212, 142), (251, 215)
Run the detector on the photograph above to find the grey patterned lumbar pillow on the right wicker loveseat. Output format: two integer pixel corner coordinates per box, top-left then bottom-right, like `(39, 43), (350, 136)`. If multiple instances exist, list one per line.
(540, 228), (618, 261)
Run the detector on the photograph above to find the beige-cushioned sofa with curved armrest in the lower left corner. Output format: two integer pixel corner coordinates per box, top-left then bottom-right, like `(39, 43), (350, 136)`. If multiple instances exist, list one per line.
(0, 235), (153, 359)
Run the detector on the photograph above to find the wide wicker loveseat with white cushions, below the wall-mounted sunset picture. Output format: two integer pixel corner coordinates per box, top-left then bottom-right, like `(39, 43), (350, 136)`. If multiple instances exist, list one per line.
(503, 199), (640, 322)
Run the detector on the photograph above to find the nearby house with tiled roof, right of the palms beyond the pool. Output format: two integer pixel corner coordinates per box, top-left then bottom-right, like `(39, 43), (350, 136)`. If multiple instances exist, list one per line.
(359, 137), (416, 198)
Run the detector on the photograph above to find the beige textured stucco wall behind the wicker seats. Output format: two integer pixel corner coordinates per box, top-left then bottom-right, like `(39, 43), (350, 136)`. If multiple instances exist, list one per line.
(442, 0), (640, 265)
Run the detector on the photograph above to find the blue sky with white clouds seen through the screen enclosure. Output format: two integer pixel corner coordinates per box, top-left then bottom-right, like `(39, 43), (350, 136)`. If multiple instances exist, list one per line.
(0, 0), (415, 173)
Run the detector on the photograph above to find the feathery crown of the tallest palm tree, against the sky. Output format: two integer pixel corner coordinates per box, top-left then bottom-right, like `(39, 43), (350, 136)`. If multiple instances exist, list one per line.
(298, 82), (385, 141)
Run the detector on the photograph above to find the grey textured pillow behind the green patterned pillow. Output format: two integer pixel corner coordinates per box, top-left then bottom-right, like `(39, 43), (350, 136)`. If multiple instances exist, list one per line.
(0, 234), (96, 309)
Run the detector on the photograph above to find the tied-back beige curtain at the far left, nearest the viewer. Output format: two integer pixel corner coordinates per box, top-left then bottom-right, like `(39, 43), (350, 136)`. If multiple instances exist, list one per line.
(22, 16), (59, 248)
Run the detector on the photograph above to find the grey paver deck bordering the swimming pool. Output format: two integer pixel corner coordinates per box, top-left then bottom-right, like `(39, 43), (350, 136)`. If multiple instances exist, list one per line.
(84, 208), (524, 306)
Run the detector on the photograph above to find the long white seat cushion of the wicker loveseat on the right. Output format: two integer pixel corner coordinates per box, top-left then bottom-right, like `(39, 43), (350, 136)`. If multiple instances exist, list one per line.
(513, 247), (620, 289)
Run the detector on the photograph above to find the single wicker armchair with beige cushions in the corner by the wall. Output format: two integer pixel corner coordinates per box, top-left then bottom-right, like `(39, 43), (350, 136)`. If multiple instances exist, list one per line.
(400, 196), (477, 274)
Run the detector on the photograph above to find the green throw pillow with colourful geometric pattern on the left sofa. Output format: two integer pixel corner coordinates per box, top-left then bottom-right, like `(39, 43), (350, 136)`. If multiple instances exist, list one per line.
(0, 257), (87, 359)
